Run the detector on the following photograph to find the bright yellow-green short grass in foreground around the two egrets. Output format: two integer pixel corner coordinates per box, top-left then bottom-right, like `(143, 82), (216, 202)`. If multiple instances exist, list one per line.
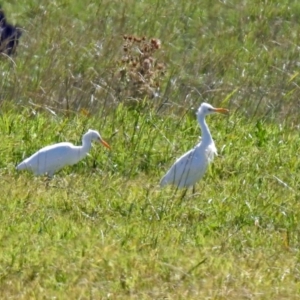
(1, 103), (300, 299)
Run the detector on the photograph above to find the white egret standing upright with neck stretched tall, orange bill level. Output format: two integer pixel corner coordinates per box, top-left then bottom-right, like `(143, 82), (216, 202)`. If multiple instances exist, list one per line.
(160, 103), (228, 188)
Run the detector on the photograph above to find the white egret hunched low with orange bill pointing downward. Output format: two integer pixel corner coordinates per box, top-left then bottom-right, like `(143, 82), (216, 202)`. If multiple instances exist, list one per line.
(17, 129), (110, 177)
